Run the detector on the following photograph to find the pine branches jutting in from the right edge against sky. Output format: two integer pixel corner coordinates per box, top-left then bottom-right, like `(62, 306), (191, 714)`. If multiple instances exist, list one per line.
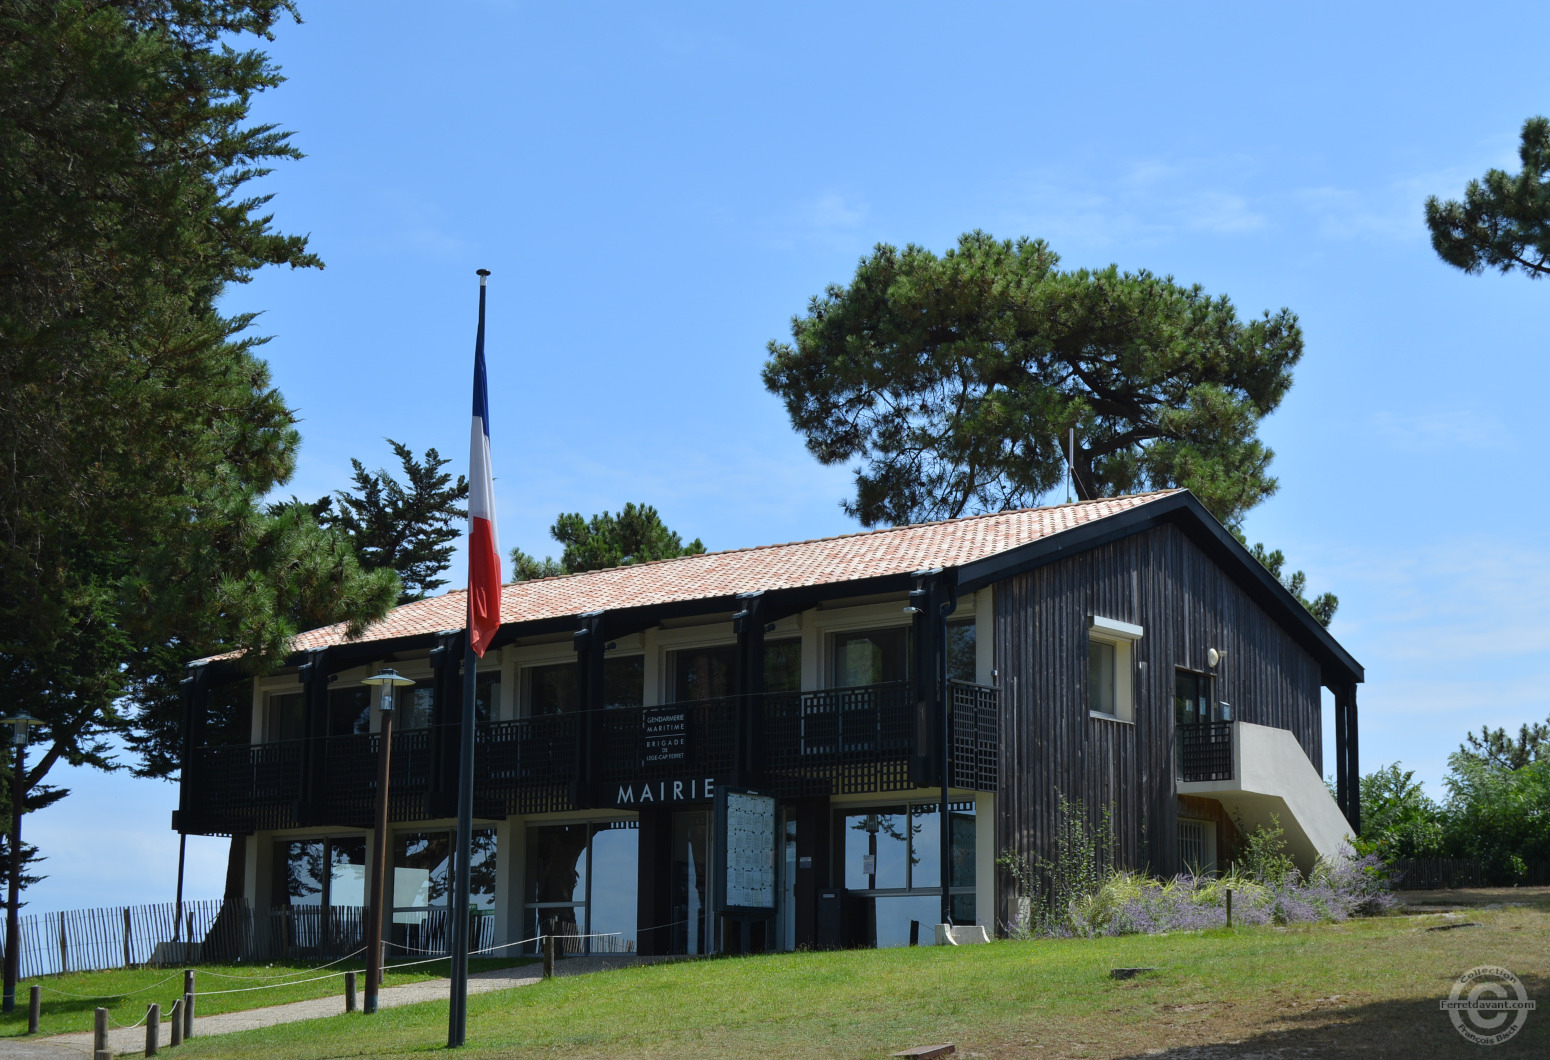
(1426, 118), (1550, 279)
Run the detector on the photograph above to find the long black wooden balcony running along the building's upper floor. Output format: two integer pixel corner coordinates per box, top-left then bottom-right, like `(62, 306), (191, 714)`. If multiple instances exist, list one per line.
(181, 682), (1000, 835)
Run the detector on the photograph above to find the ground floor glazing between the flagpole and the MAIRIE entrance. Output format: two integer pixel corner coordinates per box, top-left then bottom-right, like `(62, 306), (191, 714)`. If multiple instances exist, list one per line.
(522, 821), (640, 953)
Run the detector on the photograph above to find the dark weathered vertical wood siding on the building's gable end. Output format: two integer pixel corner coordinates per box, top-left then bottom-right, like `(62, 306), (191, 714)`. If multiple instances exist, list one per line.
(995, 525), (1322, 919)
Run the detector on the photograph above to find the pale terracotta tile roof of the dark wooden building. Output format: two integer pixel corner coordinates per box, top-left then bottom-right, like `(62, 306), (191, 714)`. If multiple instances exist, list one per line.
(251, 490), (1178, 651)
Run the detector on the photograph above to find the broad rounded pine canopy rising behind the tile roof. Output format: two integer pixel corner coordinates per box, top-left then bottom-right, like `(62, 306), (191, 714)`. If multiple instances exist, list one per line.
(764, 231), (1302, 527)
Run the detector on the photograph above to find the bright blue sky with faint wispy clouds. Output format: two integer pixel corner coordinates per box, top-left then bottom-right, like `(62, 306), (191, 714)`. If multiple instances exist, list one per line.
(28, 0), (1550, 910)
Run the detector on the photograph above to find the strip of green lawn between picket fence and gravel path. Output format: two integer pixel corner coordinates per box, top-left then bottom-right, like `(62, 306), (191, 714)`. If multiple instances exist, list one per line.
(0, 958), (524, 1037)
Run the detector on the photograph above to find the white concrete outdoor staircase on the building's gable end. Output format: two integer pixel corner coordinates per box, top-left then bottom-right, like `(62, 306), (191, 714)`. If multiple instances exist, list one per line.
(1178, 722), (1352, 872)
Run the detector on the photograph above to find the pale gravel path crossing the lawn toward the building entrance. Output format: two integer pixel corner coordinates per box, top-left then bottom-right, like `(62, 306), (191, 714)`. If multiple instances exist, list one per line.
(31, 956), (657, 1060)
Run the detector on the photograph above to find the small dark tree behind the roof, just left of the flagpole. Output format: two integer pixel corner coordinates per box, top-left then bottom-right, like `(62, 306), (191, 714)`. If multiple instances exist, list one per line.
(302, 439), (468, 603)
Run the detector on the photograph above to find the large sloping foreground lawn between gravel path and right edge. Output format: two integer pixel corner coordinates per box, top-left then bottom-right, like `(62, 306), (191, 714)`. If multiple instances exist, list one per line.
(166, 902), (1550, 1060)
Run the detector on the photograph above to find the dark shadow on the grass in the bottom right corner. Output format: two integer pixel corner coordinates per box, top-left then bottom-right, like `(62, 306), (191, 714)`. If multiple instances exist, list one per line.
(1125, 975), (1550, 1060)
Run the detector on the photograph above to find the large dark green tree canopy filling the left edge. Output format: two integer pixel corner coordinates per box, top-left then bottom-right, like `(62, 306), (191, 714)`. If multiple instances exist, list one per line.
(0, 0), (398, 807)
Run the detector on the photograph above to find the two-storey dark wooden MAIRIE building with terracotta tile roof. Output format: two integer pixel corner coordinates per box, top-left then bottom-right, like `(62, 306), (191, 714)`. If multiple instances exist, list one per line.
(175, 491), (1362, 953)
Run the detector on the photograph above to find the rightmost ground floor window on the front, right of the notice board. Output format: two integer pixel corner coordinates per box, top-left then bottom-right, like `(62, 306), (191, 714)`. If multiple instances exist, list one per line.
(837, 801), (977, 947)
